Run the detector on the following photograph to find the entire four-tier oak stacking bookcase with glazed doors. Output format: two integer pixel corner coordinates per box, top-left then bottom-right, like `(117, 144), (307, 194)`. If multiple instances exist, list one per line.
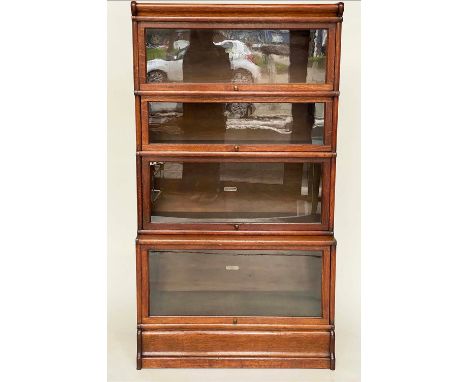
(131, 2), (344, 369)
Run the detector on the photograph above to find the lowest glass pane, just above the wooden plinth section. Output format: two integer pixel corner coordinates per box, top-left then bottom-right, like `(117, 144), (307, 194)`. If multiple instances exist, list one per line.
(149, 250), (322, 317)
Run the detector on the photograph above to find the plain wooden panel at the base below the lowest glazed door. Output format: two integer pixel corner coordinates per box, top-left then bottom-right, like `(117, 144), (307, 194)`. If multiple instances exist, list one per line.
(142, 331), (330, 358)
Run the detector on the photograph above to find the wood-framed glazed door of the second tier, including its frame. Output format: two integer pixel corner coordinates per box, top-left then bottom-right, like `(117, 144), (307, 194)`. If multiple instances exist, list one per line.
(142, 95), (333, 152)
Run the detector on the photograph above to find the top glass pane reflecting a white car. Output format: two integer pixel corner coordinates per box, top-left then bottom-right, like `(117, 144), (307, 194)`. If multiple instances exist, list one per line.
(146, 29), (327, 84)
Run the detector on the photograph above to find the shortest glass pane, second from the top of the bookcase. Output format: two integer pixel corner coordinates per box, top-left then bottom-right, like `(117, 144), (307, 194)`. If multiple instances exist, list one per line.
(148, 102), (324, 145)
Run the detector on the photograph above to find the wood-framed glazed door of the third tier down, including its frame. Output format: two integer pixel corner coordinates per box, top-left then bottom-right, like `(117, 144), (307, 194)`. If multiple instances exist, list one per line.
(142, 157), (330, 231)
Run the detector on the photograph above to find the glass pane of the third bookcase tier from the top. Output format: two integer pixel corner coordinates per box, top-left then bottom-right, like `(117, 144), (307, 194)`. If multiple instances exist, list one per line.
(150, 162), (322, 223)
